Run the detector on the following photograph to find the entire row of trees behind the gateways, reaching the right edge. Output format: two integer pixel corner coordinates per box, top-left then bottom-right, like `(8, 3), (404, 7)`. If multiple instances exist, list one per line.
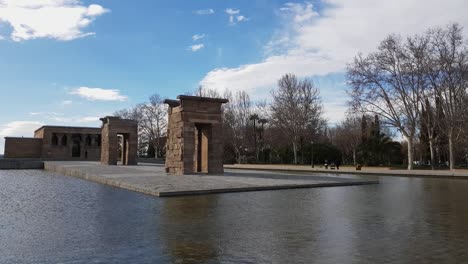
(115, 24), (468, 169)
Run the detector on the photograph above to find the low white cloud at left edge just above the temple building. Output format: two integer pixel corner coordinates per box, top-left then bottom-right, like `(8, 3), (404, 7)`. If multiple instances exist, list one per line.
(0, 121), (43, 153)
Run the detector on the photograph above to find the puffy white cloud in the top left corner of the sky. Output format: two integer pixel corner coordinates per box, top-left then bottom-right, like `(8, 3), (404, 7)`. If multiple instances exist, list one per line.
(0, 0), (109, 41)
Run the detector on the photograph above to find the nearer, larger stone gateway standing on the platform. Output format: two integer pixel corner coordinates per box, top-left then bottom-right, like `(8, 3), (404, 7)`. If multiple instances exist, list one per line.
(164, 95), (228, 175)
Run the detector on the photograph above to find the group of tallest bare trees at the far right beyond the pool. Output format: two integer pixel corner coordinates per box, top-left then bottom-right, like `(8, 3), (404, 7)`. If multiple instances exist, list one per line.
(347, 24), (468, 169)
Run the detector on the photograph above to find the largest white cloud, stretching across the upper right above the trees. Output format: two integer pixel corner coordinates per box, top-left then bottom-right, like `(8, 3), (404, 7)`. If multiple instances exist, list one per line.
(200, 0), (468, 124)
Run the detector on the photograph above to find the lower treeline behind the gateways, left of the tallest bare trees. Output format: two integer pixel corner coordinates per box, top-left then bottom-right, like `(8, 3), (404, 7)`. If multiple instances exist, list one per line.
(114, 74), (401, 165)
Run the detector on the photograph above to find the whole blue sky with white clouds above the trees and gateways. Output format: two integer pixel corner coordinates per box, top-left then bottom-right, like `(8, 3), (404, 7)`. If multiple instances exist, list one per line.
(0, 0), (468, 153)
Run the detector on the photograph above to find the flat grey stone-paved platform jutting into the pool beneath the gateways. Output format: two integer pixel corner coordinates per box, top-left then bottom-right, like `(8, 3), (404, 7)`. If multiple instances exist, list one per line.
(44, 161), (378, 196)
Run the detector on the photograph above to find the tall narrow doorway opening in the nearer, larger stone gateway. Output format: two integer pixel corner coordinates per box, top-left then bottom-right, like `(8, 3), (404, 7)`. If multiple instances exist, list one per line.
(194, 124), (211, 173)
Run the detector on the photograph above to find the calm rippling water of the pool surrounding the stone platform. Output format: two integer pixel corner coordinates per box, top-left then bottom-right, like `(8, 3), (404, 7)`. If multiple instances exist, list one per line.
(0, 171), (468, 263)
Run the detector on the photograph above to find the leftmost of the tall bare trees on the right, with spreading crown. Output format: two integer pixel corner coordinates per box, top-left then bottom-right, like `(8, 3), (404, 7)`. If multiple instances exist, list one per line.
(347, 35), (427, 170)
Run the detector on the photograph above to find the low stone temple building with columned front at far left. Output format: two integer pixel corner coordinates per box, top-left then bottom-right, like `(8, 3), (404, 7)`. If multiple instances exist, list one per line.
(4, 126), (101, 161)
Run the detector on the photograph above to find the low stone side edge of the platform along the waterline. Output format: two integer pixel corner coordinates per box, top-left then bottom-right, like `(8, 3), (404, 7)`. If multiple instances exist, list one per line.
(44, 162), (379, 197)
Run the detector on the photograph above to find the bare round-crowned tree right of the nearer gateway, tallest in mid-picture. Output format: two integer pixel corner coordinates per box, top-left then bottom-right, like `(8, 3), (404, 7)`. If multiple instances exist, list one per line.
(271, 74), (322, 163)
